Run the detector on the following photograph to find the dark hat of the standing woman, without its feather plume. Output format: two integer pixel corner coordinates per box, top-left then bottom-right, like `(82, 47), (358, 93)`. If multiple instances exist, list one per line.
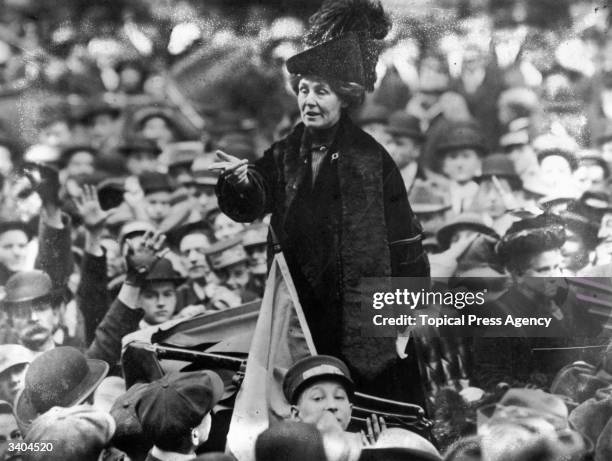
(286, 32), (365, 86)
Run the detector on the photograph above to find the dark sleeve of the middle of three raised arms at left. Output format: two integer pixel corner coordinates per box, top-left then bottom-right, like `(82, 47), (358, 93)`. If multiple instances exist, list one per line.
(76, 252), (110, 344)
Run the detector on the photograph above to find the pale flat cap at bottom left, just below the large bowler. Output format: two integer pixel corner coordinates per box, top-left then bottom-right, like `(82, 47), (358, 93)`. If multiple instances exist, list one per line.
(24, 405), (116, 461)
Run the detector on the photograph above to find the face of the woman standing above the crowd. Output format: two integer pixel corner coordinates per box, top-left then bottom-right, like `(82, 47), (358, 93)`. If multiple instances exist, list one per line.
(298, 77), (344, 130)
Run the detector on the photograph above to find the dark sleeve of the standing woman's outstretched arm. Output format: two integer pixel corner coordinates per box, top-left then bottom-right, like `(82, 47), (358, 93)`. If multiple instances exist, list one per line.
(215, 148), (277, 222)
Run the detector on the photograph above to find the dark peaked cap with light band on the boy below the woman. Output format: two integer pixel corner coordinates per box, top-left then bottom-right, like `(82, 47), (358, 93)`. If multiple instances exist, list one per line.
(283, 355), (355, 404)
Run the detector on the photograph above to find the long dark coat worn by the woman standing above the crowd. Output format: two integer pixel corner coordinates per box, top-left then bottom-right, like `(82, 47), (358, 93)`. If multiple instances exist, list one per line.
(217, 115), (429, 377)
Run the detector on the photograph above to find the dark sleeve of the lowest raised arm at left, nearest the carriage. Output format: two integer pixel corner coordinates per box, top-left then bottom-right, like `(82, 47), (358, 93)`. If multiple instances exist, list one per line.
(86, 299), (144, 368)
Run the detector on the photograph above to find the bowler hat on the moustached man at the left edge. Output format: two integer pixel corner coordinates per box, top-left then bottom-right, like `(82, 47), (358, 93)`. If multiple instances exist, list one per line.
(2, 270), (62, 308)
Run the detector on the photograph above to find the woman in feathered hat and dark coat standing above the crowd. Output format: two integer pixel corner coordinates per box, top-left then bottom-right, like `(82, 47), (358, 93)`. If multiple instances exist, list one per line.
(212, 1), (429, 396)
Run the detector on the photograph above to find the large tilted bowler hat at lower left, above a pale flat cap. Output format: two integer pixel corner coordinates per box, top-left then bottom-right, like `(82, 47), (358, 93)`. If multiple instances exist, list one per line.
(15, 346), (109, 434)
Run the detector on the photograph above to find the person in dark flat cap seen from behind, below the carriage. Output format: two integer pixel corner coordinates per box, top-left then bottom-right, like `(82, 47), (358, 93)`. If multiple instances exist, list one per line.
(135, 370), (224, 461)
